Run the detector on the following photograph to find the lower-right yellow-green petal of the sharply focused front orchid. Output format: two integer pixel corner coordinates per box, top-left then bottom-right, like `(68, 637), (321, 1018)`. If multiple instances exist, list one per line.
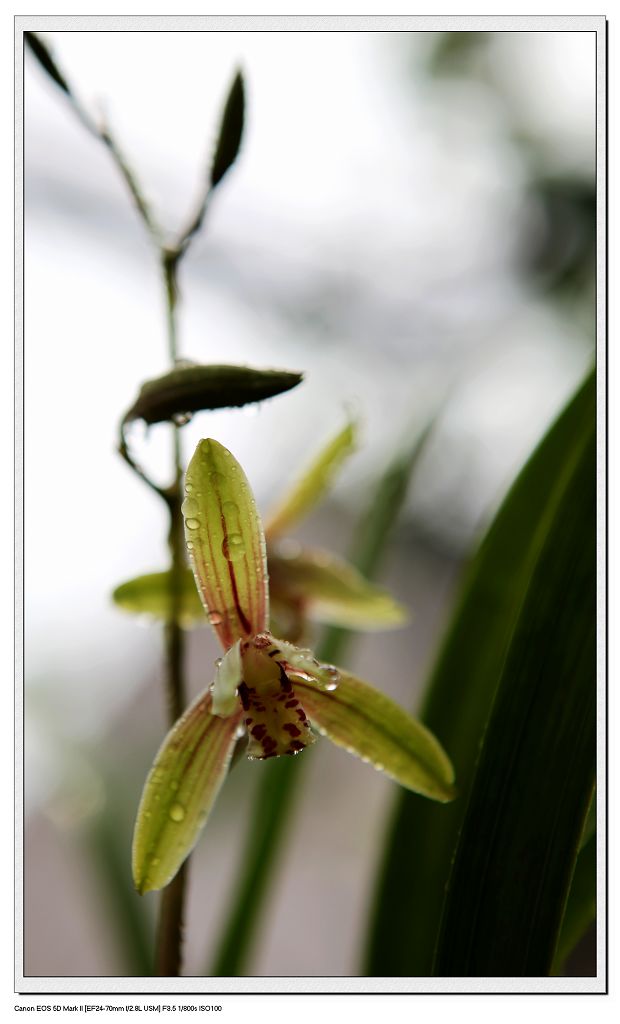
(295, 669), (455, 803)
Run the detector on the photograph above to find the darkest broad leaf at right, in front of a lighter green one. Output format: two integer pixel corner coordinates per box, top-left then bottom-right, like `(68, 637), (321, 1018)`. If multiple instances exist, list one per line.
(436, 418), (596, 977)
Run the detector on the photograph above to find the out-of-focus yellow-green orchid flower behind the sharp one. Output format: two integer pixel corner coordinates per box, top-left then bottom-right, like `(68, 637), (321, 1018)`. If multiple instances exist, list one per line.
(114, 422), (408, 642)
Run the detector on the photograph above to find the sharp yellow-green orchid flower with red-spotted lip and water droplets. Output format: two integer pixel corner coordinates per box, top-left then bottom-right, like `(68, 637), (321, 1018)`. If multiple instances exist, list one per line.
(133, 439), (454, 893)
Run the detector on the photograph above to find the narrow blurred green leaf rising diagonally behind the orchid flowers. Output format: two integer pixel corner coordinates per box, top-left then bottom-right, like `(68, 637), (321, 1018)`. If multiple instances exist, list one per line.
(209, 427), (430, 977)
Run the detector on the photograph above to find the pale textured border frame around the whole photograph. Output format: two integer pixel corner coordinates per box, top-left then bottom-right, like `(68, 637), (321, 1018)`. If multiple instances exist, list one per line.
(14, 15), (608, 996)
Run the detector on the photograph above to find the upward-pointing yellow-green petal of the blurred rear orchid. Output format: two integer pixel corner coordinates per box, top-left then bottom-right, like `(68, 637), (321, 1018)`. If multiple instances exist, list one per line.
(265, 422), (357, 540)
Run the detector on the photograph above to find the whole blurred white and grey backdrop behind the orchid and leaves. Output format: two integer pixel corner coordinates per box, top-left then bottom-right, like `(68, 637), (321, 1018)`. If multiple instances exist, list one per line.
(24, 32), (595, 977)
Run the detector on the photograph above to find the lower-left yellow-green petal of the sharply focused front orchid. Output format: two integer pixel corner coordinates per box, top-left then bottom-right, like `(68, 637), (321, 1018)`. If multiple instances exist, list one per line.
(132, 691), (241, 894)
